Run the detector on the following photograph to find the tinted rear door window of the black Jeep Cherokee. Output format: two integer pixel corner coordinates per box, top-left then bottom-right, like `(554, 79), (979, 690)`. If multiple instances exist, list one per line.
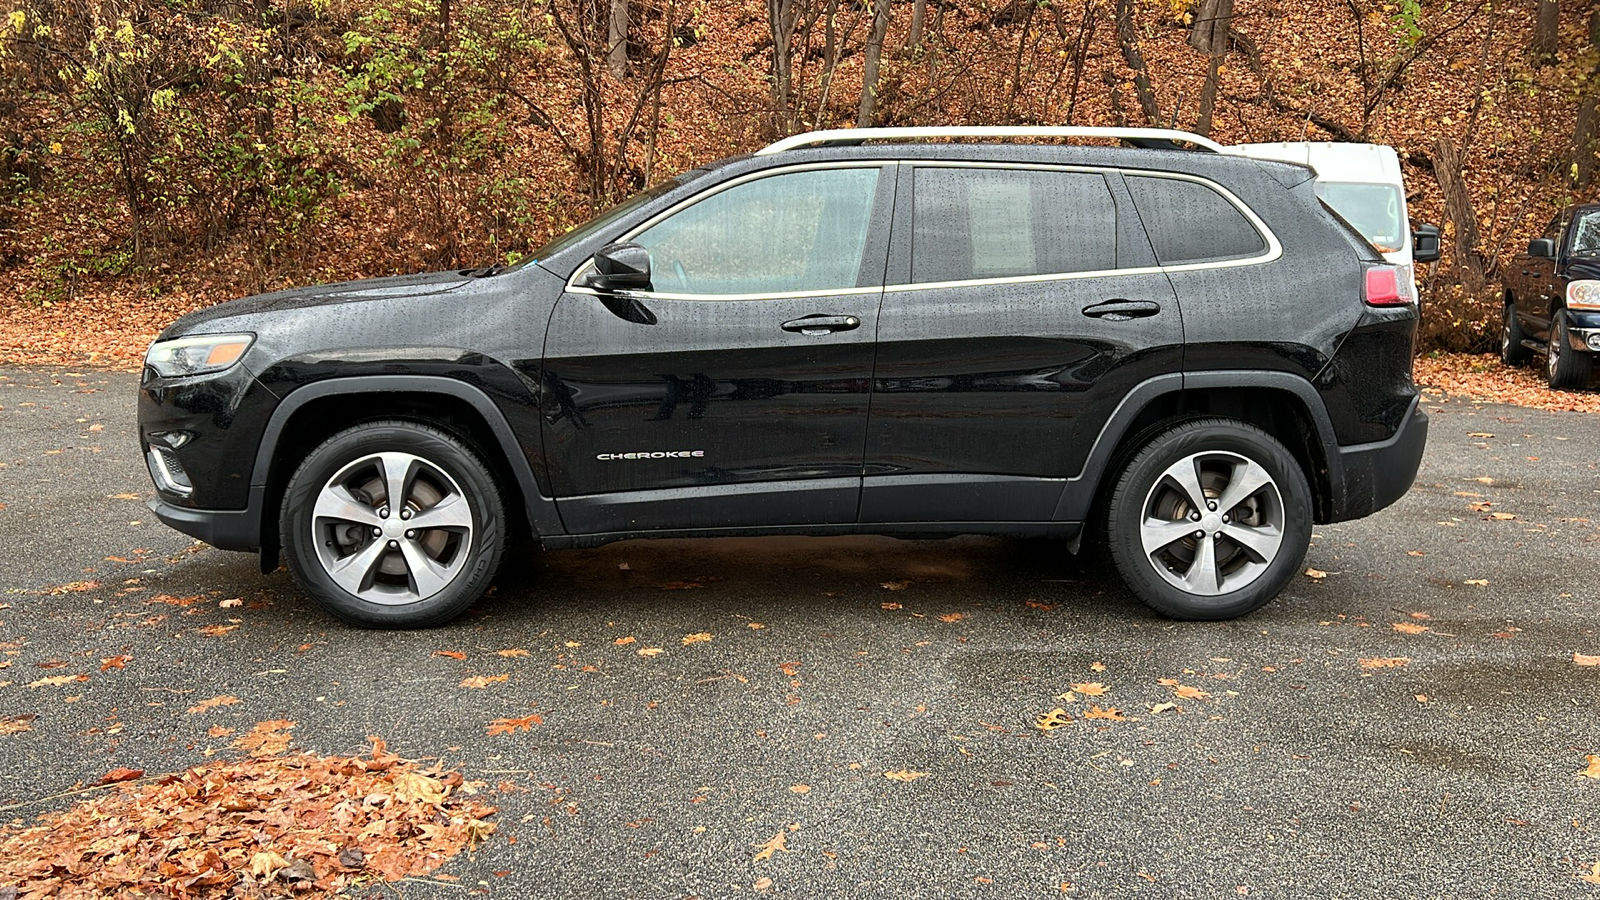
(912, 167), (1117, 283)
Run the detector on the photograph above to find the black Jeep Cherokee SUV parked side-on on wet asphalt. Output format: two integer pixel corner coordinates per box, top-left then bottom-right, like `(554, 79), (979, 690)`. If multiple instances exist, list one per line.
(139, 130), (1427, 626)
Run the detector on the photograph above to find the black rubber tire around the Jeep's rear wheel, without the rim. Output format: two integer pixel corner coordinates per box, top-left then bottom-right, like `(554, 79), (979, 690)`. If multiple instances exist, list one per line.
(1106, 418), (1312, 620)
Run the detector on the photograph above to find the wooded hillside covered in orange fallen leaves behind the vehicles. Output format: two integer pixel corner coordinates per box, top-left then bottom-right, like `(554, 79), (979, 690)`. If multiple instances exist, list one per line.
(0, 0), (1600, 364)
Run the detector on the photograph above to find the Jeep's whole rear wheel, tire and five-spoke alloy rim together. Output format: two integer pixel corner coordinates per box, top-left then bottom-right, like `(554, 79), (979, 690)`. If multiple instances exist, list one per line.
(1106, 418), (1312, 620)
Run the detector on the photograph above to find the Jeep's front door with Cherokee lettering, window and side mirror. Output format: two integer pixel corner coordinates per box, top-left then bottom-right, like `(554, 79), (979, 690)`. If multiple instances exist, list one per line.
(542, 163), (894, 535)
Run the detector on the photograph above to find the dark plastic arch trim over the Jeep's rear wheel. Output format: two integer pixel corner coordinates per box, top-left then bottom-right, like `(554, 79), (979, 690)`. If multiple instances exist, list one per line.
(1054, 370), (1344, 522)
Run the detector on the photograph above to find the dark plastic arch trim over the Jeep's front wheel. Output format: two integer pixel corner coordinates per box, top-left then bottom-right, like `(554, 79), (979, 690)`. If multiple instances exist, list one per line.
(250, 375), (566, 538)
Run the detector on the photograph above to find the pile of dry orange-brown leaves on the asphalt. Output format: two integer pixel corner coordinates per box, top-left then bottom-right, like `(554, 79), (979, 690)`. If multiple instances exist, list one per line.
(0, 722), (496, 900)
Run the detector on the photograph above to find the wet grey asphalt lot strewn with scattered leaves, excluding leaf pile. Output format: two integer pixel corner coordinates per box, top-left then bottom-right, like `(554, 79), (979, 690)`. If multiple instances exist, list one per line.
(0, 368), (1600, 898)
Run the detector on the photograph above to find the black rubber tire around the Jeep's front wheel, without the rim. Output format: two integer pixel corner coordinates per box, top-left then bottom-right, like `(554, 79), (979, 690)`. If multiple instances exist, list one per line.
(278, 421), (506, 628)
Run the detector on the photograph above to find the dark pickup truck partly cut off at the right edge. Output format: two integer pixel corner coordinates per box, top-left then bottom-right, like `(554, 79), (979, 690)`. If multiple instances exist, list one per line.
(1501, 203), (1600, 391)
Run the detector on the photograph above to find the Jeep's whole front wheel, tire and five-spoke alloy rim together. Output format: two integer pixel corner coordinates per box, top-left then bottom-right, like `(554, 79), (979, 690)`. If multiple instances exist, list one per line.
(278, 421), (507, 628)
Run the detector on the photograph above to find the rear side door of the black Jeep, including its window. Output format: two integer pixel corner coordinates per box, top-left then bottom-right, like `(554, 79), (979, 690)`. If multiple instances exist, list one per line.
(861, 163), (1182, 530)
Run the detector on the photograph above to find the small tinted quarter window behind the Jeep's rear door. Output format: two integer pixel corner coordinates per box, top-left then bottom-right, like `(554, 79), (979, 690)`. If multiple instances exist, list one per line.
(1128, 176), (1267, 266)
